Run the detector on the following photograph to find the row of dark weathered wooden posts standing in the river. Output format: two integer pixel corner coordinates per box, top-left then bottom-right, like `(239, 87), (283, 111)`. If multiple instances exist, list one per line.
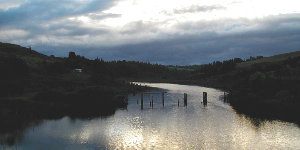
(137, 92), (207, 109)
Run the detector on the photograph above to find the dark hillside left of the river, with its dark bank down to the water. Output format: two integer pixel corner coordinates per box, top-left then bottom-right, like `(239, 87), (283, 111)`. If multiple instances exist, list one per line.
(0, 43), (183, 132)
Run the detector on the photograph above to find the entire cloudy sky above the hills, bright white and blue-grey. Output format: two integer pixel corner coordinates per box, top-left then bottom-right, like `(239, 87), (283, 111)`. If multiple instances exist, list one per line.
(0, 0), (300, 65)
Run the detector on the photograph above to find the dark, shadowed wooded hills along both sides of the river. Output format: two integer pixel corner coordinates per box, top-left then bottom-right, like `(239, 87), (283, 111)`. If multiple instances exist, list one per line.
(0, 40), (300, 122)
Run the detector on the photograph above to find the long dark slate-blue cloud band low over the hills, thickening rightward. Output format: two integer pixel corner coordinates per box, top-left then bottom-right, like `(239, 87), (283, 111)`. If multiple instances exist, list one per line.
(54, 14), (300, 65)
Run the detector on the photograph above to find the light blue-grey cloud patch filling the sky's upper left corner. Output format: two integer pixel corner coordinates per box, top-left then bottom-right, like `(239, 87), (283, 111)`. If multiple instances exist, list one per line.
(0, 0), (117, 30)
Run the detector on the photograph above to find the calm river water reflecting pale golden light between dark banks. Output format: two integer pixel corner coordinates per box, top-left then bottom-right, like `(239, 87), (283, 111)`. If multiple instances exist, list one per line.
(0, 84), (300, 150)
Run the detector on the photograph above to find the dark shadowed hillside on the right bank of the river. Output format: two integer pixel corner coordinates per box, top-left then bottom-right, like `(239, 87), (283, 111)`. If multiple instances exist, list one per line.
(188, 51), (300, 122)
